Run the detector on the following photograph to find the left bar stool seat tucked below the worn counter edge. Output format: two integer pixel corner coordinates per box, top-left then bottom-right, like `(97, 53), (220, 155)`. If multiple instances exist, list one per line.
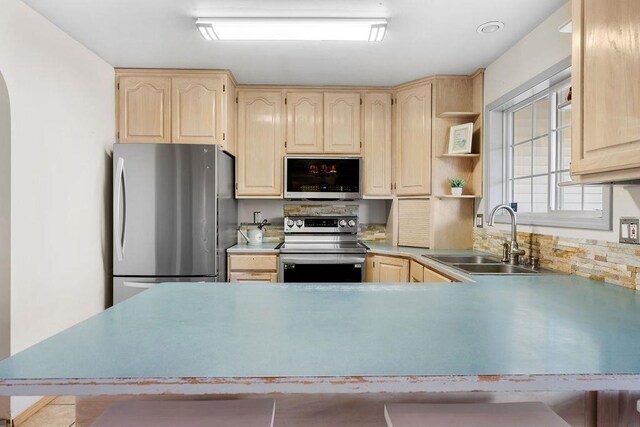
(91, 399), (276, 427)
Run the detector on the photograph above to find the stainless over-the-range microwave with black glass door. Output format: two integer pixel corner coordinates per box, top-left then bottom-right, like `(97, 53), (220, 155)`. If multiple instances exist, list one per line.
(284, 156), (362, 200)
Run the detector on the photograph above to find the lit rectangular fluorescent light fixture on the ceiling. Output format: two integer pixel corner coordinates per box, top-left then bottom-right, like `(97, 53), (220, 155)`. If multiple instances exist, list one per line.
(196, 18), (387, 42)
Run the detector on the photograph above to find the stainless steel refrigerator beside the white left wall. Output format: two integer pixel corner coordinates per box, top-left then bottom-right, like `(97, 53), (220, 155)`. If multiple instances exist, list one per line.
(113, 144), (238, 304)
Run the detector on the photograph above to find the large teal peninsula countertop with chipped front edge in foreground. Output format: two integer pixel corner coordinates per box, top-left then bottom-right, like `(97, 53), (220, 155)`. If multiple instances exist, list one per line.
(0, 275), (640, 395)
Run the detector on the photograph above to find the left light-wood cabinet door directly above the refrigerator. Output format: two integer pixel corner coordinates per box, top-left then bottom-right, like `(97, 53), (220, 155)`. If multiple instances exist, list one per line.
(118, 76), (171, 143)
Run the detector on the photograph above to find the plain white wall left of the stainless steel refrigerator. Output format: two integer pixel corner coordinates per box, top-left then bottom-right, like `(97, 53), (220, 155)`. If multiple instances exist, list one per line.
(0, 0), (115, 353)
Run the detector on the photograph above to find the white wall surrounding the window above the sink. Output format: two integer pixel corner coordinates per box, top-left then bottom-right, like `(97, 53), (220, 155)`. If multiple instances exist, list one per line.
(477, 2), (640, 241)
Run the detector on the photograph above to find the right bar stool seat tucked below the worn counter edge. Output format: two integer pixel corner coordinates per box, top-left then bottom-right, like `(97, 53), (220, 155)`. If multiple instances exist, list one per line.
(384, 402), (569, 427)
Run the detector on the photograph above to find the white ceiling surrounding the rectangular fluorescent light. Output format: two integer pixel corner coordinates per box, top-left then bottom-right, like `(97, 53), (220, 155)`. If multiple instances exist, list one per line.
(24, 0), (566, 86)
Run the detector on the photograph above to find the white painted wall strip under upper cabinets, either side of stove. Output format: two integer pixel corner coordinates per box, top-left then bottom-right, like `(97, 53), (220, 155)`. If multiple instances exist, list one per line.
(238, 199), (387, 224)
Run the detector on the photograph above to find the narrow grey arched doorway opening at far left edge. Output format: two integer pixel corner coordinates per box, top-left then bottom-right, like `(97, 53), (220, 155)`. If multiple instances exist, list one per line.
(0, 72), (11, 420)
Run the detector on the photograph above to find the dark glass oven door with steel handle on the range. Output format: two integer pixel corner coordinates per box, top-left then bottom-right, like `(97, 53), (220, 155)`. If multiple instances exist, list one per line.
(278, 254), (366, 283)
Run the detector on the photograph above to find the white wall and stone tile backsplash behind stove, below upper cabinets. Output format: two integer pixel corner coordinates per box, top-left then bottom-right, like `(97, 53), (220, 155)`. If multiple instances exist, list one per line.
(238, 199), (387, 243)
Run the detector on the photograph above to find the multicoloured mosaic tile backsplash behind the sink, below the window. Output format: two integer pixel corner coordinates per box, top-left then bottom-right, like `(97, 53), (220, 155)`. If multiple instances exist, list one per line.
(473, 228), (640, 290)
